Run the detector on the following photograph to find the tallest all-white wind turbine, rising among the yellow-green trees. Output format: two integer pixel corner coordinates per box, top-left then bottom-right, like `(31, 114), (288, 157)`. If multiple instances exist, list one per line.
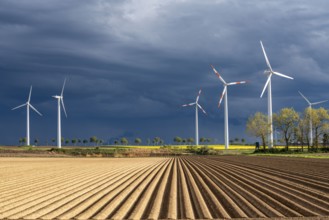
(260, 41), (294, 148)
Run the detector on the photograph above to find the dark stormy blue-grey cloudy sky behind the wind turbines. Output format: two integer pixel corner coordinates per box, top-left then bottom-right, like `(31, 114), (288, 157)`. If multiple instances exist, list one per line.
(0, 0), (329, 145)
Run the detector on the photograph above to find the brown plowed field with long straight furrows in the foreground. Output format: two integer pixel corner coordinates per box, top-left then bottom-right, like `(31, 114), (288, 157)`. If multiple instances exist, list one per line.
(0, 156), (329, 219)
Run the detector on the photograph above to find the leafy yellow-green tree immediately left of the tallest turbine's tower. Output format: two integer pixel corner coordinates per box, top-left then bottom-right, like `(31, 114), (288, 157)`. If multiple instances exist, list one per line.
(247, 112), (269, 149)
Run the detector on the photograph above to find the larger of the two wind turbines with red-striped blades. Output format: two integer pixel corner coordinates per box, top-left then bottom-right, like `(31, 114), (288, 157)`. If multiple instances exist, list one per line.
(210, 65), (247, 149)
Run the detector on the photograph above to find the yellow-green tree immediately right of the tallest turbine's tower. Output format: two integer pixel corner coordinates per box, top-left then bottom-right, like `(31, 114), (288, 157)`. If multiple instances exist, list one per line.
(273, 108), (299, 150)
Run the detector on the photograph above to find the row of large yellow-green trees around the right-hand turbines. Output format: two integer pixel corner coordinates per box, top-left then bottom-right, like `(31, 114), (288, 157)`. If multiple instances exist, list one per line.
(246, 108), (329, 150)
